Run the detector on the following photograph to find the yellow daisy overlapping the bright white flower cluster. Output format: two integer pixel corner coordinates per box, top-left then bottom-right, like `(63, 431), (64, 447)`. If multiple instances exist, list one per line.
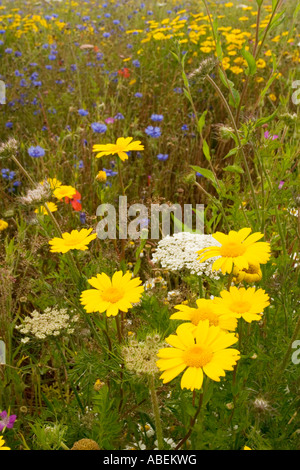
(198, 228), (270, 274)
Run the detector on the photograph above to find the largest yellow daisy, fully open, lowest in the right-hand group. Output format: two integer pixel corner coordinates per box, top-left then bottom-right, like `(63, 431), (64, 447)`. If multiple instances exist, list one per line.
(156, 320), (240, 391)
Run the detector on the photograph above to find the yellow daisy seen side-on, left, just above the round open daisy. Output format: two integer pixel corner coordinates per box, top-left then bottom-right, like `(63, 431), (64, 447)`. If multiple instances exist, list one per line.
(49, 228), (97, 253)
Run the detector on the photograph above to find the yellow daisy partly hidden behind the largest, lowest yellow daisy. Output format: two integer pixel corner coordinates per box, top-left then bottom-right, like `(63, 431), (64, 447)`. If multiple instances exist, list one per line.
(170, 299), (237, 331)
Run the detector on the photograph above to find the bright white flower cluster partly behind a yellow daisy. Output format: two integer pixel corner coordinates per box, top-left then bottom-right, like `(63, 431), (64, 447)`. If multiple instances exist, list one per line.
(152, 232), (220, 279)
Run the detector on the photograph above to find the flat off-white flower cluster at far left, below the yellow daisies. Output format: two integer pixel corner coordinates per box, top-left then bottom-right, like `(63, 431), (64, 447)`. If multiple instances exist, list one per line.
(15, 307), (79, 343)
